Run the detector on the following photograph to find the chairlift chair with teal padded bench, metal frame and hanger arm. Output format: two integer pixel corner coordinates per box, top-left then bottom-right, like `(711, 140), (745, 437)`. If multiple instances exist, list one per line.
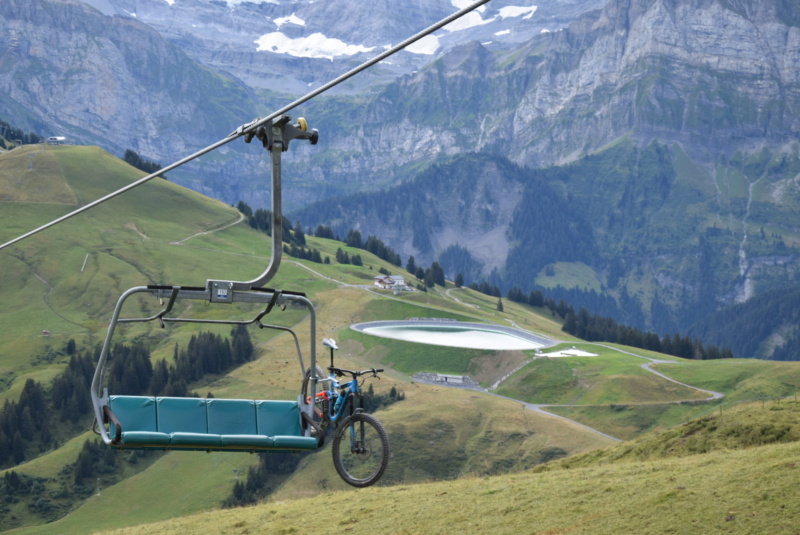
(91, 115), (328, 452)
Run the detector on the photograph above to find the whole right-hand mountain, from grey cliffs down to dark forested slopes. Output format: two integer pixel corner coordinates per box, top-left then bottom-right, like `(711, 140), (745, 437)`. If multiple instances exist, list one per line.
(286, 0), (798, 359)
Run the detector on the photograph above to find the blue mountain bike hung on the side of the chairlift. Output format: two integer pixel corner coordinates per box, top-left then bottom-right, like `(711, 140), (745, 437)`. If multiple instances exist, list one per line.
(302, 340), (389, 487)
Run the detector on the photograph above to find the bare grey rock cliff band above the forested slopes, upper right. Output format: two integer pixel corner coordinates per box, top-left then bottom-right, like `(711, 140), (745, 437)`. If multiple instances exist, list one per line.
(310, 0), (800, 177)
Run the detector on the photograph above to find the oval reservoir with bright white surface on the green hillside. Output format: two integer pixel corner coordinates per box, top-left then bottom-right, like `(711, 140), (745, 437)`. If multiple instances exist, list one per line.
(352, 320), (554, 351)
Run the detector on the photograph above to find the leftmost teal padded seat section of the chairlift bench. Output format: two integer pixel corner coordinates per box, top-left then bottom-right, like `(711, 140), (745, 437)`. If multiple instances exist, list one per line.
(108, 396), (170, 446)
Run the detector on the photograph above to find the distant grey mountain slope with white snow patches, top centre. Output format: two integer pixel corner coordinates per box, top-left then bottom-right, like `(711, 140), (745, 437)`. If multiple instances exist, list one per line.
(78, 0), (603, 94)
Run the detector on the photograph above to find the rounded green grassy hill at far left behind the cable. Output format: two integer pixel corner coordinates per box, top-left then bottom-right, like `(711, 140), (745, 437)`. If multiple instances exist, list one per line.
(0, 145), (253, 373)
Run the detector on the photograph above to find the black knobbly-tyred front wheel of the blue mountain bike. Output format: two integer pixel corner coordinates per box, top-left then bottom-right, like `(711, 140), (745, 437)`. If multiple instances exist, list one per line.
(332, 412), (389, 487)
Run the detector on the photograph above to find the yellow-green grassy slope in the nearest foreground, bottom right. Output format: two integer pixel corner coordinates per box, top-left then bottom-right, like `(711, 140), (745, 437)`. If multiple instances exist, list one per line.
(72, 406), (800, 535)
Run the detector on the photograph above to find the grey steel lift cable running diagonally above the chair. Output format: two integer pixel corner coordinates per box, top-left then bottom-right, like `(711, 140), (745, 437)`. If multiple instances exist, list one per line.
(0, 0), (490, 250)
